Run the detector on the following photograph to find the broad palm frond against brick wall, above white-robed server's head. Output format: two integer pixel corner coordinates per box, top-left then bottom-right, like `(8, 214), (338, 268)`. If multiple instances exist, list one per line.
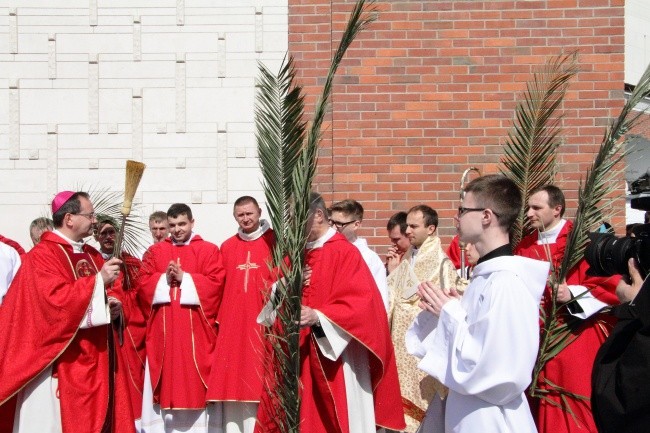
(500, 51), (578, 245)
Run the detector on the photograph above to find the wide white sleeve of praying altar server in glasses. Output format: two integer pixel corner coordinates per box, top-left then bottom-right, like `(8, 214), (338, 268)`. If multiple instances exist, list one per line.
(418, 274), (539, 405)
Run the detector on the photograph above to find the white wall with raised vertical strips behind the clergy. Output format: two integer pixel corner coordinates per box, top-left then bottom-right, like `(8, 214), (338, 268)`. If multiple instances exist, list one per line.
(0, 0), (288, 247)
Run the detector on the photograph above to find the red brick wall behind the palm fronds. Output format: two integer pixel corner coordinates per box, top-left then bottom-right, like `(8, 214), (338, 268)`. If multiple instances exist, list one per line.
(289, 0), (624, 254)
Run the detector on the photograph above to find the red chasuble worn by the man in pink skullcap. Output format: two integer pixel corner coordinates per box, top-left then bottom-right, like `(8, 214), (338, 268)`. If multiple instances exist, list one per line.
(0, 232), (135, 433)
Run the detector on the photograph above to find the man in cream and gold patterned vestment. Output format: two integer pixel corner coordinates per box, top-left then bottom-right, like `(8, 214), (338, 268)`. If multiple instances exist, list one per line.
(388, 204), (462, 433)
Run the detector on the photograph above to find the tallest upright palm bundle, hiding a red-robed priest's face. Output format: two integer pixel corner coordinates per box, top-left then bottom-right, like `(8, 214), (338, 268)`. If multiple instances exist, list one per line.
(255, 1), (376, 433)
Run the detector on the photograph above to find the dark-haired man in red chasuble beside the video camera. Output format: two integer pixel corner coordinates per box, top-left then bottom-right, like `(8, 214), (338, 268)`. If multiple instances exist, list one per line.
(515, 185), (620, 433)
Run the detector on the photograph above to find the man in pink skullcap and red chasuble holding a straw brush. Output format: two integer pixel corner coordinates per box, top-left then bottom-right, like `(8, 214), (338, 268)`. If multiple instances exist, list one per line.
(0, 191), (135, 433)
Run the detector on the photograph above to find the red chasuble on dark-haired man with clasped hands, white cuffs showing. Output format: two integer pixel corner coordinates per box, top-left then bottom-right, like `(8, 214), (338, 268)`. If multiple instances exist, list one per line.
(138, 235), (225, 409)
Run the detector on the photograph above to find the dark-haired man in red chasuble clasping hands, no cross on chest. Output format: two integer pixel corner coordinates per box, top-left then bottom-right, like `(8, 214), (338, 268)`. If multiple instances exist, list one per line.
(138, 203), (225, 433)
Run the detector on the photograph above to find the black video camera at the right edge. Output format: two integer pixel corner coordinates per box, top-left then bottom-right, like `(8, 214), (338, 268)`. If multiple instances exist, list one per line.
(585, 192), (650, 278)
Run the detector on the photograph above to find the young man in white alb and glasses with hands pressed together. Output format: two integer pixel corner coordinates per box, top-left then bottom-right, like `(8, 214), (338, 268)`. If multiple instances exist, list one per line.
(406, 175), (549, 433)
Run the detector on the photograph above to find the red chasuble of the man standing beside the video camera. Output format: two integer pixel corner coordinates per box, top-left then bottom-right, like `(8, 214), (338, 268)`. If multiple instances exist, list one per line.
(515, 221), (620, 433)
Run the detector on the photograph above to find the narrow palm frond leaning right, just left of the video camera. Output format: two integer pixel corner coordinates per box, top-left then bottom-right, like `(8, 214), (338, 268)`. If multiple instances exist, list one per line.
(530, 62), (650, 415)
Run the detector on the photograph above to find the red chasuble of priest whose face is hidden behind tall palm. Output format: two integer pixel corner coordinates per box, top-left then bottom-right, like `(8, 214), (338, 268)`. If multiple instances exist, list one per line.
(256, 233), (406, 433)
